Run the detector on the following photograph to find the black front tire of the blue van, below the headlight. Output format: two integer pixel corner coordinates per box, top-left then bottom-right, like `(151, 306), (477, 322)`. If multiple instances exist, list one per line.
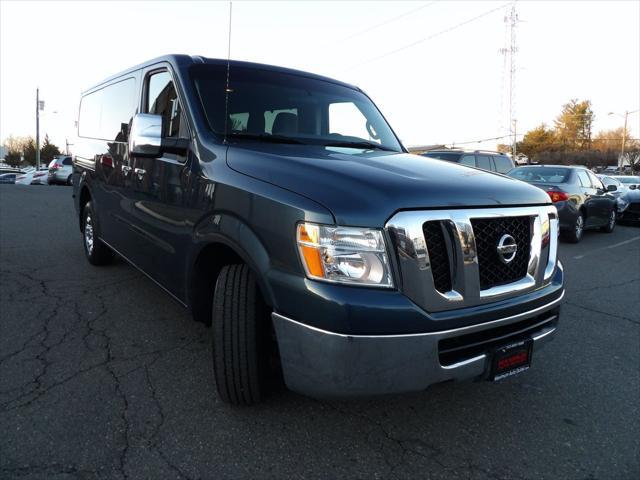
(212, 264), (268, 405)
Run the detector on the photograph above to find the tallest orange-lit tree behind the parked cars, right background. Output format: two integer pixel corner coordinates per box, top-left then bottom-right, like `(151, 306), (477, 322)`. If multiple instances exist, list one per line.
(555, 98), (594, 151)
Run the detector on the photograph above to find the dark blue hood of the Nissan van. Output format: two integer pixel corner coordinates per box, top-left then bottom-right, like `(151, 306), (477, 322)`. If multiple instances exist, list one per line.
(227, 143), (549, 227)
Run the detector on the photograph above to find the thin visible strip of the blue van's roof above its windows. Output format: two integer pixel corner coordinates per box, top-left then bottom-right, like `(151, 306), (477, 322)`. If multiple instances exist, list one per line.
(82, 54), (360, 95)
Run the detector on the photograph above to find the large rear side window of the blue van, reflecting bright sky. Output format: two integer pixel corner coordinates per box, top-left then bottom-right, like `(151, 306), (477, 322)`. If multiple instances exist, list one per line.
(78, 78), (136, 142)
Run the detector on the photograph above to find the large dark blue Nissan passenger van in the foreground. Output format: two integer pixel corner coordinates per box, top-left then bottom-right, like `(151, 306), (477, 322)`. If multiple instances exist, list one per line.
(73, 55), (564, 404)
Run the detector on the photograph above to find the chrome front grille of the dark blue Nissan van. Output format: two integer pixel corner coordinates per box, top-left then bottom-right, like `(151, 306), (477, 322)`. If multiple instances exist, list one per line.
(385, 205), (558, 312)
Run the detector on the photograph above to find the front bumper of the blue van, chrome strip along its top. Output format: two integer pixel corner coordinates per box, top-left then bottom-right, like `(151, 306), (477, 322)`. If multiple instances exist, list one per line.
(272, 292), (564, 397)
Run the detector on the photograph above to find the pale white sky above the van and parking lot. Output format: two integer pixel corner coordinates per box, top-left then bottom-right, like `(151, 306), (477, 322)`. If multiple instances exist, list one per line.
(0, 0), (640, 152)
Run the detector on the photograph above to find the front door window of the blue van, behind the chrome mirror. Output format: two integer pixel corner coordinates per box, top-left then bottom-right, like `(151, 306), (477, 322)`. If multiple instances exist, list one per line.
(145, 71), (187, 137)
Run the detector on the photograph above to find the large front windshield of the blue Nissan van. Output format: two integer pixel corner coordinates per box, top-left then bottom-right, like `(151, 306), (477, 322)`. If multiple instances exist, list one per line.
(191, 65), (402, 152)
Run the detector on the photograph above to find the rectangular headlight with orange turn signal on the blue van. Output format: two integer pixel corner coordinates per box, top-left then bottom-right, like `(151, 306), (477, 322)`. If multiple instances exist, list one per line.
(297, 223), (393, 287)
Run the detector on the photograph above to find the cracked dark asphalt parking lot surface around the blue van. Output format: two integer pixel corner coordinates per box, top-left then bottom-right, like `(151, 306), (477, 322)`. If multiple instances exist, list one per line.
(0, 185), (640, 480)
